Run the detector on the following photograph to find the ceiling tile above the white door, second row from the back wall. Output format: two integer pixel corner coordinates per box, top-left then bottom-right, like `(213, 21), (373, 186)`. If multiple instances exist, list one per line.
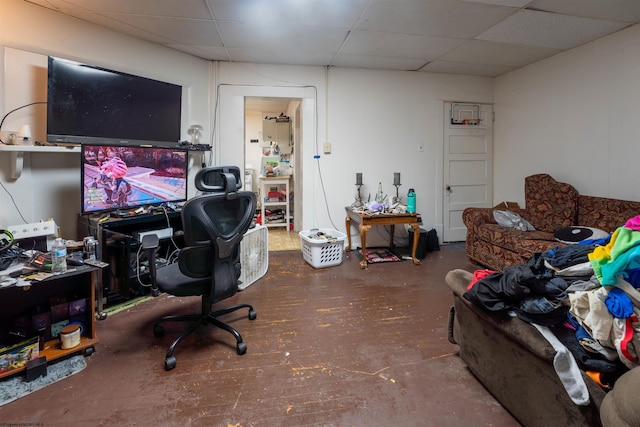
(438, 40), (562, 67)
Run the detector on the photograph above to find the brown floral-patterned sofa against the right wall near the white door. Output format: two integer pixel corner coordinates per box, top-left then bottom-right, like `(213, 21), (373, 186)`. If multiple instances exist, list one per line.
(462, 174), (640, 271)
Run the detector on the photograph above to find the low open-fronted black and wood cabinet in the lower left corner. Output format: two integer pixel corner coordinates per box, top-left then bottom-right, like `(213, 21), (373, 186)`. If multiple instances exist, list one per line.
(0, 265), (99, 378)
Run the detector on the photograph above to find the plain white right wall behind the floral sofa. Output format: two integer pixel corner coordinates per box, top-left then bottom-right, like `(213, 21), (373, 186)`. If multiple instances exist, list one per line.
(494, 26), (640, 205)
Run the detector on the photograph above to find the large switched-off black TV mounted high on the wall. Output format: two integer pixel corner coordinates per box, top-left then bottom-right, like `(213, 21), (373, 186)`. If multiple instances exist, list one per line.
(47, 57), (182, 147)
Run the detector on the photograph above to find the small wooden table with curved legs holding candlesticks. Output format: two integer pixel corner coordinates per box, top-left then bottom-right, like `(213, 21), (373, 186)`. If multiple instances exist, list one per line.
(345, 206), (420, 268)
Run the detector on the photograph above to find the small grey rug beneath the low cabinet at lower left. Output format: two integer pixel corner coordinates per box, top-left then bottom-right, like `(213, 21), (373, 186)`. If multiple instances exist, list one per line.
(0, 354), (87, 406)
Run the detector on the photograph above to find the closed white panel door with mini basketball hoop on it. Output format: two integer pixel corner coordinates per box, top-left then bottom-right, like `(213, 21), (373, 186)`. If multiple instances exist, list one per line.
(442, 102), (493, 242)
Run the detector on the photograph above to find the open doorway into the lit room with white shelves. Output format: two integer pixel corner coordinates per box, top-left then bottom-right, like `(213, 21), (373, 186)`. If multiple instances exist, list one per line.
(244, 96), (302, 250)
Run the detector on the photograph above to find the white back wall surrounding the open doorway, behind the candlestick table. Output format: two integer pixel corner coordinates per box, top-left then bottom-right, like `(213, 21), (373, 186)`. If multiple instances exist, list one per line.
(216, 63), (493, 244)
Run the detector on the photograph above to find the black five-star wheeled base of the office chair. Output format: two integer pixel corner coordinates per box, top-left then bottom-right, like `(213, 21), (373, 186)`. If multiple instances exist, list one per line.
(153, 304), (257, 371)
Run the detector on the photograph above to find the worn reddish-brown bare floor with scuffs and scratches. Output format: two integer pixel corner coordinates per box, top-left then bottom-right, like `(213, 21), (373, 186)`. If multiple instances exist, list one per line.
(0, 244), (519, 427)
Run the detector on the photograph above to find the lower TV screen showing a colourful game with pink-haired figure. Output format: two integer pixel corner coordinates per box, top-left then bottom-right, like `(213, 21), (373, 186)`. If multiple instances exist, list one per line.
(80, 144), (188, 214)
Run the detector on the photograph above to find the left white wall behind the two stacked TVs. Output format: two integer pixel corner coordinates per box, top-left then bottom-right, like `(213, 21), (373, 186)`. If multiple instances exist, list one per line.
(0, 0), (213, 238)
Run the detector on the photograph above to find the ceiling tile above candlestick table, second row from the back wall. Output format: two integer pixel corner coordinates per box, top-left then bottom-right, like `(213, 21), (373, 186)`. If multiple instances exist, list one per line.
(340, 30), (463, 59)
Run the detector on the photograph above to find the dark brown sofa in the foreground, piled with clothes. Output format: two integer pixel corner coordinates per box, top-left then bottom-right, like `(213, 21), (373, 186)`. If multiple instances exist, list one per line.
(445, 269), (640, 427)
